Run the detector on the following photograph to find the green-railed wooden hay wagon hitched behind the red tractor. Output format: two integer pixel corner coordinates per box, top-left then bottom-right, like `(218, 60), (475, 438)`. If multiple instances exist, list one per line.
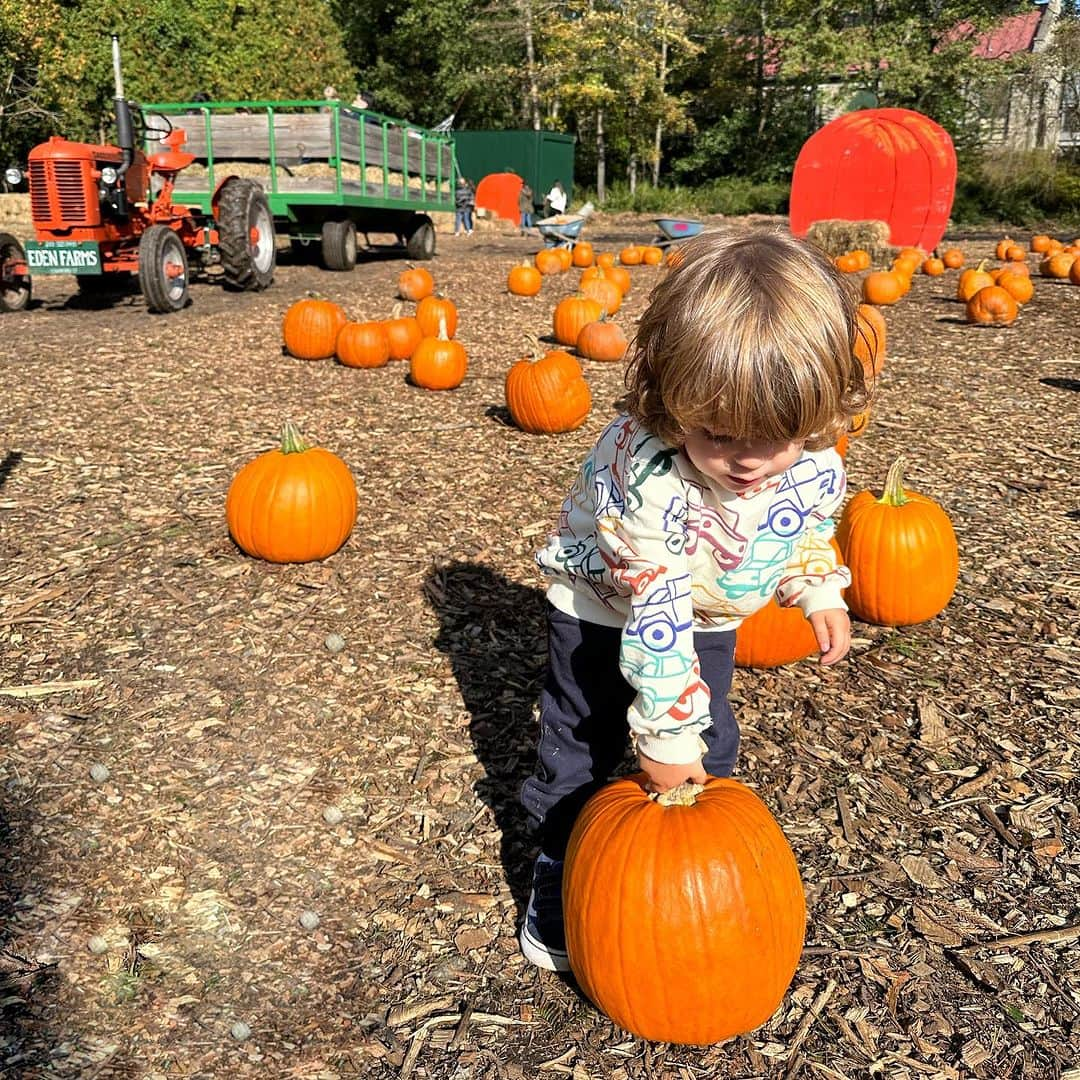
(143, 100), (457, 270)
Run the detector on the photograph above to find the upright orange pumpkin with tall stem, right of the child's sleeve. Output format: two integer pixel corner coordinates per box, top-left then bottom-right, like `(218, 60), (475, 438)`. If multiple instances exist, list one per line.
(836, 458), (959, 626)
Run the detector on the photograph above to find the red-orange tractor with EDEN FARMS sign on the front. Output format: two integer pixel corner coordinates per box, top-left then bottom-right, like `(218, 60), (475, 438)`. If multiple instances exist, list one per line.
(0, 35), (276, 312)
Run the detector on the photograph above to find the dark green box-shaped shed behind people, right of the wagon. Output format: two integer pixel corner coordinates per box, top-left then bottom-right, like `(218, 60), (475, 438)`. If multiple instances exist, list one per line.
(454, 130), (575, 206)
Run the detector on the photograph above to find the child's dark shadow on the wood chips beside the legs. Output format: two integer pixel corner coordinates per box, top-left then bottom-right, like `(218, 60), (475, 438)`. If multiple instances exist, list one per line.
(424, 563), (548, 910)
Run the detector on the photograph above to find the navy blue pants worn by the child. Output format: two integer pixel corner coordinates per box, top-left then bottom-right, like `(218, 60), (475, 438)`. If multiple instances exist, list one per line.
(522, 604), (739, 859)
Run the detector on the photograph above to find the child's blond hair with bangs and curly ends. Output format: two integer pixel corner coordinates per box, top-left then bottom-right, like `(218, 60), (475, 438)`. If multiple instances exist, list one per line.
(626, 228), (870, 449)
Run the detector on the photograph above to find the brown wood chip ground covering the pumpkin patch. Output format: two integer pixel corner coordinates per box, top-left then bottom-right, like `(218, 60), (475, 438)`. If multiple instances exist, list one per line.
(0, 206), (1080, 1080)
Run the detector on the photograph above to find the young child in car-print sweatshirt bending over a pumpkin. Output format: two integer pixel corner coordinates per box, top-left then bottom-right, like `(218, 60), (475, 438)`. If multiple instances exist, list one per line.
(519, 229), (868, 971)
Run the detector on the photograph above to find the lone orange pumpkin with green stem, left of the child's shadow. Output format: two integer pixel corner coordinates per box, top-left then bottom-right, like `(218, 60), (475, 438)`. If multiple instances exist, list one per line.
(225, 420), (356, 563)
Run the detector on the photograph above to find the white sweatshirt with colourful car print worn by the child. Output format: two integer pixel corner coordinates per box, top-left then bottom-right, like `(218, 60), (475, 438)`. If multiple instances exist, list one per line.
(537, 416), (851, 765)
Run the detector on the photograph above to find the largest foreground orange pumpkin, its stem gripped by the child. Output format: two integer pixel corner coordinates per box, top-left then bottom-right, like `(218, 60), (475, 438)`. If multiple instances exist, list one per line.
(563, 775), (806, 1045)
